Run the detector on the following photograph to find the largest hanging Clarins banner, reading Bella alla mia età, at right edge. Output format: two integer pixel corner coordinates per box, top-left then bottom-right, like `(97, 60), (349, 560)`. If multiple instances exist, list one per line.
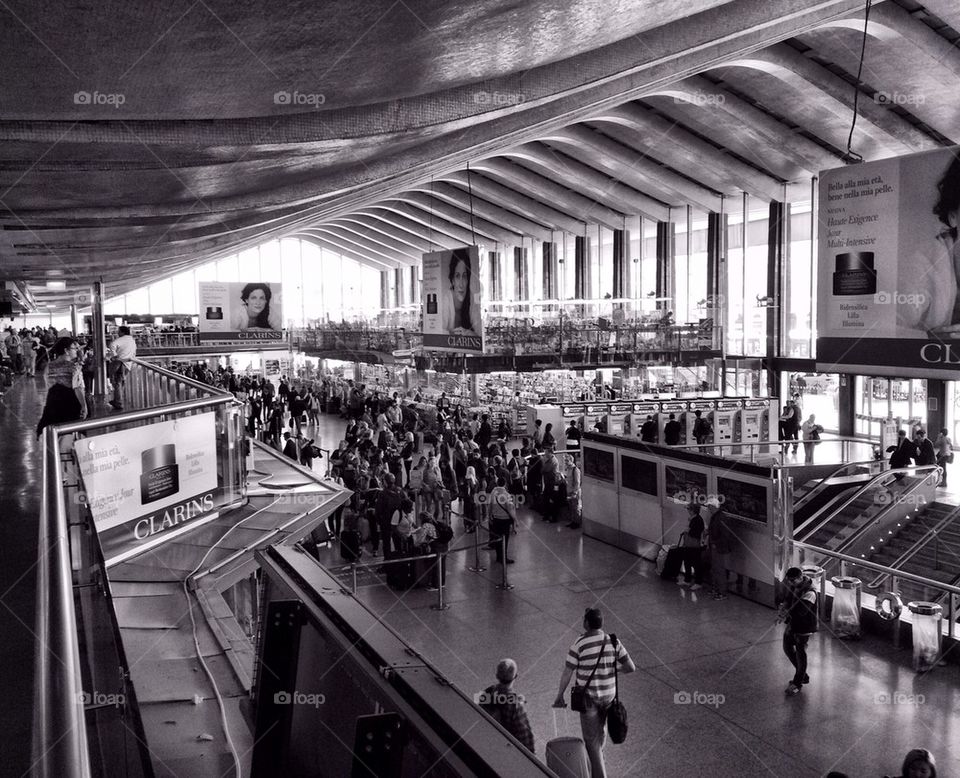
(817, 147), (960, 372)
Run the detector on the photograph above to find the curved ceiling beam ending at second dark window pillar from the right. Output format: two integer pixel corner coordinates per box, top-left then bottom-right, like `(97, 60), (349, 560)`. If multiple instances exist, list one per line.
(545, 124), (720, 211)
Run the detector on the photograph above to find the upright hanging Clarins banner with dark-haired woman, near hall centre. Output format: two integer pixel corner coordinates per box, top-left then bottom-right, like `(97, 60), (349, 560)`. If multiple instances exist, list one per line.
(423, 246), (483, 354)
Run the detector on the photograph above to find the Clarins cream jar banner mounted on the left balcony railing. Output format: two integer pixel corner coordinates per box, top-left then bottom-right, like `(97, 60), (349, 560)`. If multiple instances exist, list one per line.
(76, 412), (220, 566)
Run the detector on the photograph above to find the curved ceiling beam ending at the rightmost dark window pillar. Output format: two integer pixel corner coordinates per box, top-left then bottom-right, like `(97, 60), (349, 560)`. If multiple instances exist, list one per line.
(590, 103), (783, 201)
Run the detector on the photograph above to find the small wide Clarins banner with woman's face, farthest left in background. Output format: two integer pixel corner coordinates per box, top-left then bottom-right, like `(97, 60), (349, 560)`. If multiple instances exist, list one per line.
(198, 281), (283, 340)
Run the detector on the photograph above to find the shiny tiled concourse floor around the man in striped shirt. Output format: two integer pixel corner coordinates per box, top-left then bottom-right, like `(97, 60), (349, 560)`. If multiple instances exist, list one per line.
(310, 410), (960, 778)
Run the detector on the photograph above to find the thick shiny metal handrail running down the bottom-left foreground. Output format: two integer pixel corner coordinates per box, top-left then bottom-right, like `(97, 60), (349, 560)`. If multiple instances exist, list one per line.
(31, 427), (91, 778)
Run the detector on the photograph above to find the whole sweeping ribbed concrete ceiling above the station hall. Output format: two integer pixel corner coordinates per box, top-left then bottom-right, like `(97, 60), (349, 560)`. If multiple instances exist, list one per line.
(0, 0), (960, 305)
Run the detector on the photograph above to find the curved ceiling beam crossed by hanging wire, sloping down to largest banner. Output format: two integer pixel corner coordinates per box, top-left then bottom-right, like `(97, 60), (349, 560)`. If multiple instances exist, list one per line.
(723, 42), (940, 154)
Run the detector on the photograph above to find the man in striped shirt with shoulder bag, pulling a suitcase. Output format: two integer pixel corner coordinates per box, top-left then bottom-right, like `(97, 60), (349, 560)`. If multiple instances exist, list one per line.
(553, 608), (637, 778)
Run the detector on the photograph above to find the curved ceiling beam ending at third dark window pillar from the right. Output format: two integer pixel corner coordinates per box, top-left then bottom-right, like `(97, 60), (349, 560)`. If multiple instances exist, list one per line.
(501, 143), (669, 221)
